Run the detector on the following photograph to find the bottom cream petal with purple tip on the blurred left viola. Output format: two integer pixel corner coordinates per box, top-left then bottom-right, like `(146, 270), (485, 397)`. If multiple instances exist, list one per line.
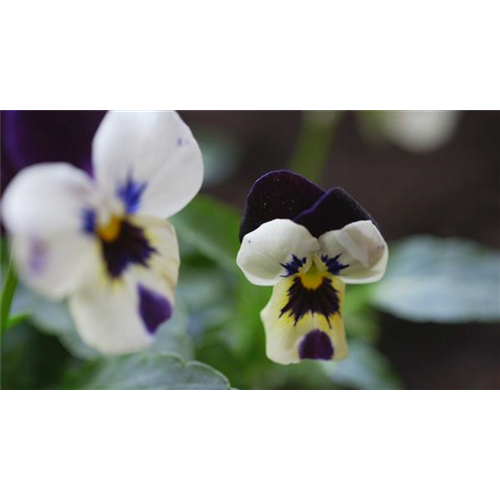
(70, 216), (180, 354)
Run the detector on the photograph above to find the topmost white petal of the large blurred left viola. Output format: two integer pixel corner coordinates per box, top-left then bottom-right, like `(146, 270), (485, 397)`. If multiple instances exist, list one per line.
(93, 111), (203, 218)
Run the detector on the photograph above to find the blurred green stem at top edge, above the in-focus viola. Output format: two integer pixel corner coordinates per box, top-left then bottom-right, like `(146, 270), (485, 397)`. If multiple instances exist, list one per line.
(290, 111), (341, 182)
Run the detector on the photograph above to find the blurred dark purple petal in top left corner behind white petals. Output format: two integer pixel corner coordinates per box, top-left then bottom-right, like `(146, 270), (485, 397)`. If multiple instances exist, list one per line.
(2, 110), (106, 173)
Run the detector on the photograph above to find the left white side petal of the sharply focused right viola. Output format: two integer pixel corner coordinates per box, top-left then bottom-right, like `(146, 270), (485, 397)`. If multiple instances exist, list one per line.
(236, 219), (319, 286)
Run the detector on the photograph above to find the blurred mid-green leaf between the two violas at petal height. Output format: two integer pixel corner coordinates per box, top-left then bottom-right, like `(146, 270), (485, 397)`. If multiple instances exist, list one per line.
(172, 195), (240, 272)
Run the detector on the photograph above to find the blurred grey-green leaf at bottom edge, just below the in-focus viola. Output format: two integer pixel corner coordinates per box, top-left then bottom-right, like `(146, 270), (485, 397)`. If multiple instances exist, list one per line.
(321, 340), (402, 399)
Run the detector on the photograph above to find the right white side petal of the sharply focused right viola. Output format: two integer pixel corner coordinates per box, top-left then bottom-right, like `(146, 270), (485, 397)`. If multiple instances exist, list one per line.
(319, 221), (389, 283)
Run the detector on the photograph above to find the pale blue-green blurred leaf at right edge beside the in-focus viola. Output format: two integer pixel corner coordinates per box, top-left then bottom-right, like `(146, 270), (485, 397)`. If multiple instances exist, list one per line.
(373, 236), (500, 323)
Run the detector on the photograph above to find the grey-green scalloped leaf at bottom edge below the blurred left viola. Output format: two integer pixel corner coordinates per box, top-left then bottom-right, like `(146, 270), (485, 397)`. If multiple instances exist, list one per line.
(71, 353), (229, 389)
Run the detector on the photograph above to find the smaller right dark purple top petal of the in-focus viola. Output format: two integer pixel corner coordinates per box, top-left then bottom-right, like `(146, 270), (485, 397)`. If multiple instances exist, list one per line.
(293, 187), (377, 238)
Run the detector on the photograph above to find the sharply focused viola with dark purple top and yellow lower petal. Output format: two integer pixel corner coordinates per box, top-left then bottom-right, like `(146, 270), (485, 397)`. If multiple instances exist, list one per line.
(237, 170), (388, 364)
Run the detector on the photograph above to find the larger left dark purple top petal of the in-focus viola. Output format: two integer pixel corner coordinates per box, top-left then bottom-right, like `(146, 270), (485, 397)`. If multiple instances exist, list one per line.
(240, 170), (324, 241)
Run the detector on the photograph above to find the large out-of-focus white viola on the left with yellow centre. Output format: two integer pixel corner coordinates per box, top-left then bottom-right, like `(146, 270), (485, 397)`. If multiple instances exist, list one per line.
(1, 111), (203, 354)
